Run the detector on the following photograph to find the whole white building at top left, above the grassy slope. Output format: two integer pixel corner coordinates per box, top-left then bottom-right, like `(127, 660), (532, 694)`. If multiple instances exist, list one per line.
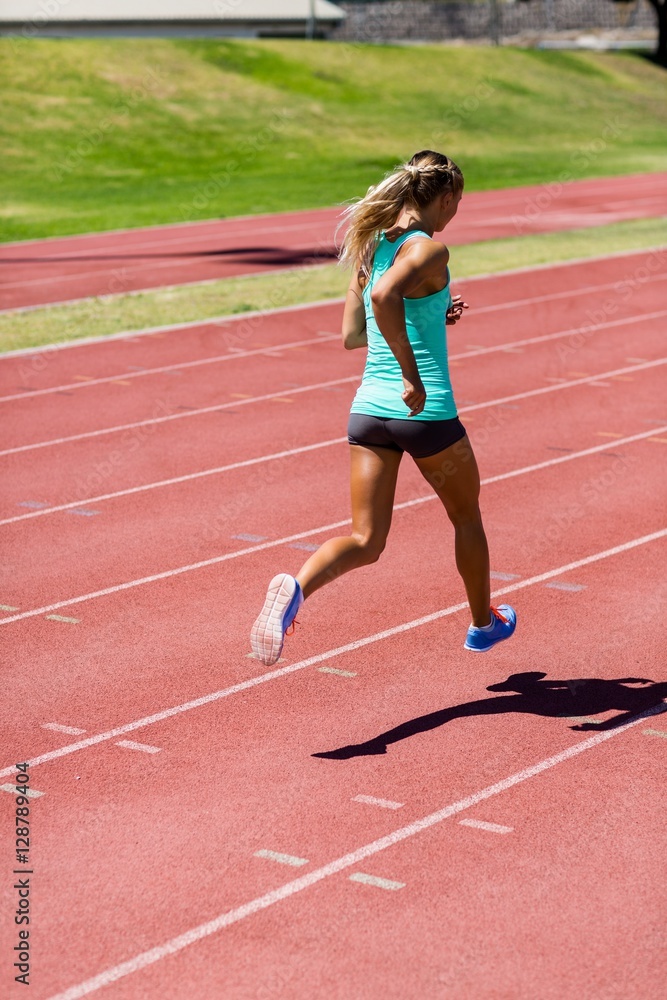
(0, 0), (345, 38)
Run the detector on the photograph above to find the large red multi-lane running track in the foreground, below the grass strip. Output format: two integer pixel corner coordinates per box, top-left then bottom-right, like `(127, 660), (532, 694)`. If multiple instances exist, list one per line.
(0, 246), (667, 1000)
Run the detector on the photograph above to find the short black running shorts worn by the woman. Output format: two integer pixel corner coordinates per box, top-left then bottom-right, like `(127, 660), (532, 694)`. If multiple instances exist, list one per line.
(347, 413), (466, 458)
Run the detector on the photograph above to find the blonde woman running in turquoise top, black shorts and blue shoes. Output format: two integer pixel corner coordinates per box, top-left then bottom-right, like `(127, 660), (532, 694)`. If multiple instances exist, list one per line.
(250, 150), (516, 666)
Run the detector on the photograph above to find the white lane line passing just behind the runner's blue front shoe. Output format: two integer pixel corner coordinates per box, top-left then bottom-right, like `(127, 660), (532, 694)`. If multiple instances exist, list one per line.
(0, 528), (667, 778)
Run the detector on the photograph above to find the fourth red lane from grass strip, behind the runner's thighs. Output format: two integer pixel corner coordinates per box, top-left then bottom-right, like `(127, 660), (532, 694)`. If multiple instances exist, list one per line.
(2, 352), (664, 619)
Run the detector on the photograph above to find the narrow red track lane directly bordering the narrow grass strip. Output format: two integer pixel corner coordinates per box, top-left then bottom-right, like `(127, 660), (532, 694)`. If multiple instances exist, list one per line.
(0, 250), (667, 396)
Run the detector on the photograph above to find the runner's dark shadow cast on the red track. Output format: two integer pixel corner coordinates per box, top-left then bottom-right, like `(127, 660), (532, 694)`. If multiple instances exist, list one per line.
(311, 671), (667, 760)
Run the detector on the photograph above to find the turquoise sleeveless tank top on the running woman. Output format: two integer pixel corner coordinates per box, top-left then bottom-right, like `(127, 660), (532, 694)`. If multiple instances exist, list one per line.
(350, 230), (457, 420)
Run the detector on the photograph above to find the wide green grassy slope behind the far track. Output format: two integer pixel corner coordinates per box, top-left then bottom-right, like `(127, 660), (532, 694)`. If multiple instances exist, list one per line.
(0, 38), (667, 240)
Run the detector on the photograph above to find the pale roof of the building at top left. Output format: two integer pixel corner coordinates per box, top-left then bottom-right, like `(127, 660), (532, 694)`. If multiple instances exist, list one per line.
(0, 0), (345, 26)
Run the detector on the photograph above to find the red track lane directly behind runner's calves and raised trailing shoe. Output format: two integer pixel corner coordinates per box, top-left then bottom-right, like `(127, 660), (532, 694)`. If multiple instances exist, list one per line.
(4, 422), (660, 756)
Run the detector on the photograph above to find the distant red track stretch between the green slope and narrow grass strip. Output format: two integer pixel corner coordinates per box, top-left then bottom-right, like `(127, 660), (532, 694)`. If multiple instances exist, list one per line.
(0, 173), (667, 309)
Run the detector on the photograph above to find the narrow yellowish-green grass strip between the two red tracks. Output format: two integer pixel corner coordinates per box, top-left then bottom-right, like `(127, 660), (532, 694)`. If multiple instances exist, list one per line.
(0, 218), (667, 353)
